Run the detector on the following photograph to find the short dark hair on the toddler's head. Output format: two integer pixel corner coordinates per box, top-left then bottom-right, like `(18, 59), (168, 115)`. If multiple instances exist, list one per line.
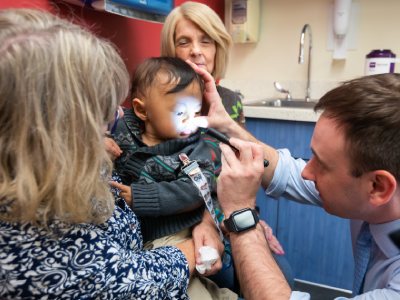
(131, 57), (204, 98)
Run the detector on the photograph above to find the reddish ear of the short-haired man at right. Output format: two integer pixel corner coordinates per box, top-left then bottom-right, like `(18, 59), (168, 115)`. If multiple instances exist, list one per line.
(369, 170), (397, 206)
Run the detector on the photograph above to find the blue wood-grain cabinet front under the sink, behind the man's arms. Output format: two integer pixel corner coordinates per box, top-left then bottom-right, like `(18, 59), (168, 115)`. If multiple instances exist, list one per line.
(246, 118), (354, 289)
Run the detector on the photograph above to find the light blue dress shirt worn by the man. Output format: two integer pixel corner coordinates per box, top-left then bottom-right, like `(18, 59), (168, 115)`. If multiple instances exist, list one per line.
(265, 149), (400, 300)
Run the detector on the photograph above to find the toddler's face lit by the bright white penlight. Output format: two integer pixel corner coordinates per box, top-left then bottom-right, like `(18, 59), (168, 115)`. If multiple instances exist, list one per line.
(144, 75), (202, 142)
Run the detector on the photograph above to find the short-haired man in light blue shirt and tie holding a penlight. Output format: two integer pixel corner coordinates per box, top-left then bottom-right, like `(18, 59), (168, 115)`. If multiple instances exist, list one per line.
(192, 65), (400, 300)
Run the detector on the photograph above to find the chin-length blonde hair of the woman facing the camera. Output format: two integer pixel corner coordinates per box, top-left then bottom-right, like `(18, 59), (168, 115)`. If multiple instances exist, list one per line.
(161, 1), (232, 79)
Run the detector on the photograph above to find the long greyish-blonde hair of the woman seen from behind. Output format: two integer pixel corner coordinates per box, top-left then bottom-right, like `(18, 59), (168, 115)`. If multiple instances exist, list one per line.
(0, 9), (129, 225)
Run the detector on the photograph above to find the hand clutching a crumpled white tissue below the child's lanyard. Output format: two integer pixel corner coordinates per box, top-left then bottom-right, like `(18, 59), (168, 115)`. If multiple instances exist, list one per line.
(192, 210), (224, 276)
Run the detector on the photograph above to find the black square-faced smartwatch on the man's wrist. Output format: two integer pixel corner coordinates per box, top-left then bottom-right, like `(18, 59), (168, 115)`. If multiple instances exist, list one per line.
(224, 208), (259, 232)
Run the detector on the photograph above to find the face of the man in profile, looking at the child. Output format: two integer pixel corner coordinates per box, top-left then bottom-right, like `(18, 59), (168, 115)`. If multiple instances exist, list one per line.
(302, 114), (369, 219)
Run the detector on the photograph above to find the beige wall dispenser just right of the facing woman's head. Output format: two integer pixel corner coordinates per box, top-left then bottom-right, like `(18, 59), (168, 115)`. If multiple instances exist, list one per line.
(225, 0), (260, 43)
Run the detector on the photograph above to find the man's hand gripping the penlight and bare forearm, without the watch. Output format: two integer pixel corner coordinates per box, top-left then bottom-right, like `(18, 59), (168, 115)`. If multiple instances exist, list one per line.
(217, 138), (291, 299)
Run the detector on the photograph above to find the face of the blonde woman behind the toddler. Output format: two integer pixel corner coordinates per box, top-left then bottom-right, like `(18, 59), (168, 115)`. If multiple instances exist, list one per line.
(175, 18), (217, 73)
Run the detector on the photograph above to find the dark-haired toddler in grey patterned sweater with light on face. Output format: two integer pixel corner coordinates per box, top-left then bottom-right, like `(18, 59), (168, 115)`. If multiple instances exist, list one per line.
(108, 57), (237, 299)
